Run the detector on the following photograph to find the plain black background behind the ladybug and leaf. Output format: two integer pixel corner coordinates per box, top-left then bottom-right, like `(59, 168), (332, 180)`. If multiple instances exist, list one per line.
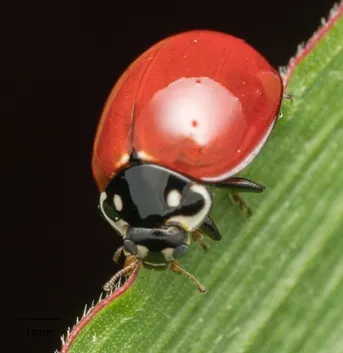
(0, 0), (334, 353)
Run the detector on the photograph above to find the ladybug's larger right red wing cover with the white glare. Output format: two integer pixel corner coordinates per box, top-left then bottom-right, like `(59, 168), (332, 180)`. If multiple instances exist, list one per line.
(132, 31), (282, 180)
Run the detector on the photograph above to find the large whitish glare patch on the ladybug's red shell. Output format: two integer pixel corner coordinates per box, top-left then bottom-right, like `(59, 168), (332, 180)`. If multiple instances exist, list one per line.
(150, 77), (242, 146)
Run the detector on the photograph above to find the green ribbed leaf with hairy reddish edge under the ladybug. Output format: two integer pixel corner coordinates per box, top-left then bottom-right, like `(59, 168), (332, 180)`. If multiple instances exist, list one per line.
(63, 5), (343, 353)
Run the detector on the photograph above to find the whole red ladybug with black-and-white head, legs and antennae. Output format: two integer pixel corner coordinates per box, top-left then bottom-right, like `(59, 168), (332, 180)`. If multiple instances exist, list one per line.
(92, 30), (283, 293)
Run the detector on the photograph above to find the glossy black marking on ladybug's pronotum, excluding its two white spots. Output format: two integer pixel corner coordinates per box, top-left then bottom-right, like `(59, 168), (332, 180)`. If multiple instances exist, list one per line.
(103, 164), (205, 228)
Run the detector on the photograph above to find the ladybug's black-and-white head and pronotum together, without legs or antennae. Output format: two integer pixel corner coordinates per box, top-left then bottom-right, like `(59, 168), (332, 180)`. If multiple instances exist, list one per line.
(100, 164), (212, 266)
